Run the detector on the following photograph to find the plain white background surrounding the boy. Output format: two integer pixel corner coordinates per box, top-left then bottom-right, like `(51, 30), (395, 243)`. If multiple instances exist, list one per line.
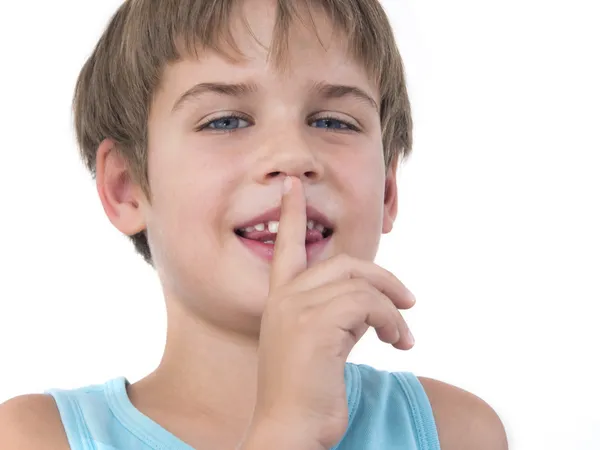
(0, 0), (600, 450)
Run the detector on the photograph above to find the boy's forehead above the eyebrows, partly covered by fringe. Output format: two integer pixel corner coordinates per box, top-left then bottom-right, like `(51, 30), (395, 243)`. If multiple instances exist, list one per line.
(157, 0), (377, 94)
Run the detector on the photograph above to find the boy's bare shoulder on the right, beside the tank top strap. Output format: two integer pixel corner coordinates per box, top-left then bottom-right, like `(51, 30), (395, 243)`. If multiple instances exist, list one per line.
(418, 377), (508, 450)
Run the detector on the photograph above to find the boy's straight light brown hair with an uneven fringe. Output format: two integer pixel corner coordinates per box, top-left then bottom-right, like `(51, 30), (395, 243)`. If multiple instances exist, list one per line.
(73, 0), (412, 265)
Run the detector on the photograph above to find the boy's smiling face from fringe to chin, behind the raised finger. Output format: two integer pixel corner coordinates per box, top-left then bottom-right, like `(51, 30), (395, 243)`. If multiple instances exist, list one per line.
(133, 0), (396, 326)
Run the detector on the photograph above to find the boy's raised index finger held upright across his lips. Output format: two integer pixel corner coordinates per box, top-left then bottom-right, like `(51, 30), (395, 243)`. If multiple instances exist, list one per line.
(270, 177), (307, 291)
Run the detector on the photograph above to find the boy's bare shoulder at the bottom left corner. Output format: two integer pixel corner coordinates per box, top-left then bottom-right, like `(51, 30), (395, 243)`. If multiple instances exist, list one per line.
(0, 394), (70, 450)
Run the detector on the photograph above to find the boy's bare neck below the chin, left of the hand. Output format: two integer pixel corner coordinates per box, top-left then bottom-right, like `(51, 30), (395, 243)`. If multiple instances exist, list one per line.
(130, 301), (258, 432)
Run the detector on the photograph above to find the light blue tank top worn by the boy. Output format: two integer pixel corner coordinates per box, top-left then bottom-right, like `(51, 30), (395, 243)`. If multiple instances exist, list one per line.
(46, 363), (440, 450)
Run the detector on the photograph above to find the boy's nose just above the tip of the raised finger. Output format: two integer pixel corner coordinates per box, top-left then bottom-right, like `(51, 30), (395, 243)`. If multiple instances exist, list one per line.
(254, 128), (324, 184)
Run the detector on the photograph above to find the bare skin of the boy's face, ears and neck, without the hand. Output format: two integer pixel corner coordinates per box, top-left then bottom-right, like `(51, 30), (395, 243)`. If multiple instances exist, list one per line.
(97, 1), (397, 443)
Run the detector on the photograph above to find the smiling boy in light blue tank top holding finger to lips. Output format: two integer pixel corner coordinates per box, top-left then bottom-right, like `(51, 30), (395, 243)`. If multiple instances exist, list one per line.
(0, 0), (507, 450)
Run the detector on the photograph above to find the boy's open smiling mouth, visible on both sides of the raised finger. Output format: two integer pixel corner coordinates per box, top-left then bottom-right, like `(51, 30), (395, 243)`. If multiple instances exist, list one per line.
(234, 207), (335, 259)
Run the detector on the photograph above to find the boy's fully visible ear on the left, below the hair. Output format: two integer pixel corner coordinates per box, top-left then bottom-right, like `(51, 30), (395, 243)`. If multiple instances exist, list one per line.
(96, 139), (146, 236)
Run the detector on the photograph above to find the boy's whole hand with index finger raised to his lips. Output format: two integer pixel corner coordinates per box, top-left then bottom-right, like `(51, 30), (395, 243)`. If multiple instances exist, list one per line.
(246, 178), (415, 449)
